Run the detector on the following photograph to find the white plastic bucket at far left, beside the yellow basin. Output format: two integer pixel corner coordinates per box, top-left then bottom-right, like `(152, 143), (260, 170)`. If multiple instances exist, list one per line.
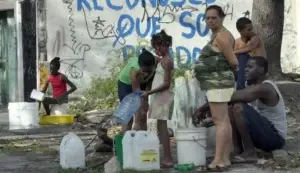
(8, 102), (40, 130)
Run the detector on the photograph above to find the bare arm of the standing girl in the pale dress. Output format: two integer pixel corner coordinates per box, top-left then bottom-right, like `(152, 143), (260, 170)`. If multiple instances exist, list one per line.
(147, 60), (173, 95)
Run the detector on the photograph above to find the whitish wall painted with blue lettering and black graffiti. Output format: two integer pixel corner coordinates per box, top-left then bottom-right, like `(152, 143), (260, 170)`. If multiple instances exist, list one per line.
(46, 0), (300, 88)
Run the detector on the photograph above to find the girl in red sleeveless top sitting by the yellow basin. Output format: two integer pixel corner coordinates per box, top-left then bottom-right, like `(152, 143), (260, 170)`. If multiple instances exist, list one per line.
(42, 57), (77, 115)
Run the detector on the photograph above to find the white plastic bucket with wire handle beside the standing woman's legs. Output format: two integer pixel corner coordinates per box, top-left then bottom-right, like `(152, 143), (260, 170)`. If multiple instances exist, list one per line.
(175, 128), (206, 166)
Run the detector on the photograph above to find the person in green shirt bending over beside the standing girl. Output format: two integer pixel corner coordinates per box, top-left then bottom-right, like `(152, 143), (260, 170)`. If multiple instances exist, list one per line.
(118, 49), (156, 131)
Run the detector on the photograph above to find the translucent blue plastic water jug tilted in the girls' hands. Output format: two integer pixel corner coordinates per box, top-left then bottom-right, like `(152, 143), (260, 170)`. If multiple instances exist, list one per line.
(114, 91), (142, 124)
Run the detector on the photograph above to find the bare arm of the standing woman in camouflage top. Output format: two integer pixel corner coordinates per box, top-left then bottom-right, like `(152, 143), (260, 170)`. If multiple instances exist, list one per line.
(216, 32), (238, 71)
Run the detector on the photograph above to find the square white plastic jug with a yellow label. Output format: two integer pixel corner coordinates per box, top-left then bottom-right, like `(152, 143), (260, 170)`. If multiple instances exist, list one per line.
(122, 131), (160, 171)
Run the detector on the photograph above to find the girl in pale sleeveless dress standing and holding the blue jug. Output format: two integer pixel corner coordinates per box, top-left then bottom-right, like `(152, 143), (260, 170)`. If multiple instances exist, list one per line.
(143, 30), (174, 167)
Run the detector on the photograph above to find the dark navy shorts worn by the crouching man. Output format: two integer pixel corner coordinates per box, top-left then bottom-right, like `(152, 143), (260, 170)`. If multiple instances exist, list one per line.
(243, 104), (285, 152)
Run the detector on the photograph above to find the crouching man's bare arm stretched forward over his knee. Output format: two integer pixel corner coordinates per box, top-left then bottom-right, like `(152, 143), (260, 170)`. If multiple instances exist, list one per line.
(229, 83), (272, 104)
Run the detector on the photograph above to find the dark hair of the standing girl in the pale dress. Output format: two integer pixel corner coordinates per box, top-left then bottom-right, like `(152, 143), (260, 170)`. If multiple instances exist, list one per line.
(151, 30), (173, 47)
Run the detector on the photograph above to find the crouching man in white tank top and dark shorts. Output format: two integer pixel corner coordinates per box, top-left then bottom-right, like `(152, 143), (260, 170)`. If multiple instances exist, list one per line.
(193, 57), (286, 162)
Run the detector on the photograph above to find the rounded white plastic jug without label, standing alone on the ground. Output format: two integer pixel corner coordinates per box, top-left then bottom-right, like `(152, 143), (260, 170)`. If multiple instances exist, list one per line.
(60, 133), (85, 169)
